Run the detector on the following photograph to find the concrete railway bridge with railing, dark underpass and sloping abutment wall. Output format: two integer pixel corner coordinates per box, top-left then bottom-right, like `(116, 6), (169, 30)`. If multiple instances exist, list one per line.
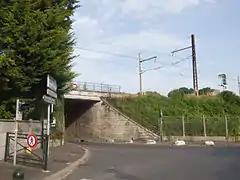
(64, 83), (156, 141)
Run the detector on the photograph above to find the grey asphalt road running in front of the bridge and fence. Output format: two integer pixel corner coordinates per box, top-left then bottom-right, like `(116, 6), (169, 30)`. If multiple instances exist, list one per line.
(67, 144), (240, 180)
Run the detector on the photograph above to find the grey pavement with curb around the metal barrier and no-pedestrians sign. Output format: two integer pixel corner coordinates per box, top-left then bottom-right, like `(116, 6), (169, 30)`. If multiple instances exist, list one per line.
(0, 143), (86, 180)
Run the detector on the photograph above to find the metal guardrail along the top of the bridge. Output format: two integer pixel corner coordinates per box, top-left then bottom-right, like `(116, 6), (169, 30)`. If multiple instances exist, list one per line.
(72, 82), (121, 93)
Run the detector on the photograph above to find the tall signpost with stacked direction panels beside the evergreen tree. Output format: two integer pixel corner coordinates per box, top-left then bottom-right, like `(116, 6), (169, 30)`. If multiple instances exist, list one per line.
(43, 75), (58, 156)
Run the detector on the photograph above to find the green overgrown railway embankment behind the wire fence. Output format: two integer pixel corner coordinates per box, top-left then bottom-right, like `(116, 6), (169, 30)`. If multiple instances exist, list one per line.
(107, 88), (240, 135)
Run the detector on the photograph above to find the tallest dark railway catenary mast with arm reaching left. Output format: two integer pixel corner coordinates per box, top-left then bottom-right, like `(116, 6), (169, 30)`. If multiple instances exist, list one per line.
(172, 34), (199, 96)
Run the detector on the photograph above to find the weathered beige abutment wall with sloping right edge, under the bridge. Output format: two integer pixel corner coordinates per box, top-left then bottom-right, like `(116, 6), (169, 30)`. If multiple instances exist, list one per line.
(66, 101), (158, 141)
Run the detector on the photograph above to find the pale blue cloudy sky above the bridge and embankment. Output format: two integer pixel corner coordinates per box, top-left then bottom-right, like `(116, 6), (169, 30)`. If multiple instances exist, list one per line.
(72, 0), (240, 95)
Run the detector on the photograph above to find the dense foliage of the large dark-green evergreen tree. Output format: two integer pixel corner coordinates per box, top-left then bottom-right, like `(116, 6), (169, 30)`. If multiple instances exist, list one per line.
(0, 0), (78, 116)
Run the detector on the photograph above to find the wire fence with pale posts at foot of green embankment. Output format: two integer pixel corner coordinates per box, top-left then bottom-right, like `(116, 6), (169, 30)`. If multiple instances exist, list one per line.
(162, 115), (240, 137)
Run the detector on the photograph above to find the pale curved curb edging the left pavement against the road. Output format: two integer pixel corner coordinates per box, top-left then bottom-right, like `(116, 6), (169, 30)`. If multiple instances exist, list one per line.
(43, 146), (91, 180)
